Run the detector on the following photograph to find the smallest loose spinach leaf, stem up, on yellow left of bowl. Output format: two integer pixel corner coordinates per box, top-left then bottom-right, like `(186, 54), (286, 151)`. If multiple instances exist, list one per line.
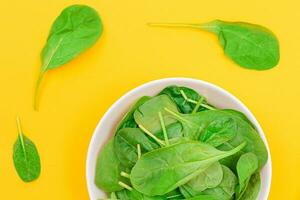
(13, 117), (41, 182)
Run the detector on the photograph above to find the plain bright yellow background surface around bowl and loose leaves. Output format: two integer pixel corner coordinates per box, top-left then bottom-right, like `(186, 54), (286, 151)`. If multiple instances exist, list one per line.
(0, 0), (300, 200)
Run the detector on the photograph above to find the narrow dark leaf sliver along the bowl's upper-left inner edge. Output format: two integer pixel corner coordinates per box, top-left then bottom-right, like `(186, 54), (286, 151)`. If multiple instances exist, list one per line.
(117, 96), (151, 131)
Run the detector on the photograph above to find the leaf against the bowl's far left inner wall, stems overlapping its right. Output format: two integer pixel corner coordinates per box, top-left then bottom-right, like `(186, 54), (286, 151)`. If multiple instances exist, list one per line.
(95, 139), (127, 192)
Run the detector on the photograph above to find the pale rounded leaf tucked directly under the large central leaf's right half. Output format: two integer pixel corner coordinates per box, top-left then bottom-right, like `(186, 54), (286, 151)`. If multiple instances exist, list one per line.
(185, 162), (223, 193)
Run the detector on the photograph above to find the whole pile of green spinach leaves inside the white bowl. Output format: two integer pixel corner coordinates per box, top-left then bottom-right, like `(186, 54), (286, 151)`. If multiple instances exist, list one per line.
(95, 86), (268, 200)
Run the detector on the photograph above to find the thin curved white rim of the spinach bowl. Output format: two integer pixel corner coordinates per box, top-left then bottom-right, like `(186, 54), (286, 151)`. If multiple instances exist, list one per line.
(85, 77), (272, 200)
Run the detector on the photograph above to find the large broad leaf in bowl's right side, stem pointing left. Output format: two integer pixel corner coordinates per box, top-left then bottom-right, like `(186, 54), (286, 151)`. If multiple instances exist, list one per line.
(168, 110), (268, 169)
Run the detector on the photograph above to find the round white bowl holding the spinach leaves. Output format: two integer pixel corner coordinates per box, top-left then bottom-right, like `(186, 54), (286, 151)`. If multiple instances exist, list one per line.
(86, 78), (272, 200)
